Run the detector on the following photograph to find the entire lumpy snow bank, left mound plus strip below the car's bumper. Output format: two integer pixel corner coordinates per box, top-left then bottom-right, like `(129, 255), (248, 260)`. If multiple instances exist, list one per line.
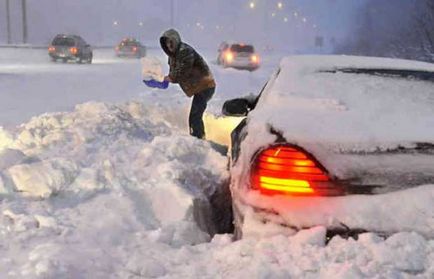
(0, 100), (434, 278)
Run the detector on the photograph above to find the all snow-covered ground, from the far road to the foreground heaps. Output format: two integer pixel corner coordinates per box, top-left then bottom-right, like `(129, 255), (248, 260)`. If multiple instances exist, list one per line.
(0, 49), (434, 278)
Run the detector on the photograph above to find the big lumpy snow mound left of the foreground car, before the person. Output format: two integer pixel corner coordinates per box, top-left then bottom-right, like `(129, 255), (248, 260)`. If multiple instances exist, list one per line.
(0, 102), (227, 278)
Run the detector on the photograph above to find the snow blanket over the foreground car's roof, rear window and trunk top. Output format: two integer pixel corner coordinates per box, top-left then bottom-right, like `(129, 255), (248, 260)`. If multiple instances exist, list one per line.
(250, 56), (434, 149)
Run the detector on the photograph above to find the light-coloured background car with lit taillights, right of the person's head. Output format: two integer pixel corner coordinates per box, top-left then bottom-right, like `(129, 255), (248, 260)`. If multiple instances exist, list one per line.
(217, 42), (260, 71)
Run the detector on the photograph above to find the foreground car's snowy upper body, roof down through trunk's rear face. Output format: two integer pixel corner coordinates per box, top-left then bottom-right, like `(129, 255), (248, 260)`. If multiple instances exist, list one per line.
(244, 56), (434, 190)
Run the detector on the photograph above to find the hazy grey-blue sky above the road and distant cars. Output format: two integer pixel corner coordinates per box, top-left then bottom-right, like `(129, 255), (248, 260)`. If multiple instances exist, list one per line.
(0, 0), (363, 51)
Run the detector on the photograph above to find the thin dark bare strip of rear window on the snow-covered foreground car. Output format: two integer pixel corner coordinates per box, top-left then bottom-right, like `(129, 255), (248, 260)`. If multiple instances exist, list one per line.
(320, 68), (434, 82)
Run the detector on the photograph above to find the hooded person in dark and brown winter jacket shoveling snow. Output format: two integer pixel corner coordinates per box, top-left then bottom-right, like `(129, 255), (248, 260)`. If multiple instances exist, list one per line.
(160, 29), (216, 139)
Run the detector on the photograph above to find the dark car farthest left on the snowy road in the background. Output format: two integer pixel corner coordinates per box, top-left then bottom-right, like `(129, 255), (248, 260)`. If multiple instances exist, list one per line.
(48, 34), (93, 64)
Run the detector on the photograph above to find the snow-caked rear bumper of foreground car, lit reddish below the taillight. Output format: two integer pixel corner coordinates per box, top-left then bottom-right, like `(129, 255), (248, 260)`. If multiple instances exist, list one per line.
(233, 185), (434, 238)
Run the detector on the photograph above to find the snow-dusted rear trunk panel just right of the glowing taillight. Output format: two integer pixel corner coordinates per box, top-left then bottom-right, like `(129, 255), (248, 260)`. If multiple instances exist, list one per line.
(307, 143), (434, 194)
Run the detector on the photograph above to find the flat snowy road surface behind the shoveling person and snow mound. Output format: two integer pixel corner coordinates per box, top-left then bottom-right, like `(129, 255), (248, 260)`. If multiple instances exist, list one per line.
(0, 48), (279, 127)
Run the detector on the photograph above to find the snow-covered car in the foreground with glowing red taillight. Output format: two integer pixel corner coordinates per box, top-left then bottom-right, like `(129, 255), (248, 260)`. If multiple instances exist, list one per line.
(223, 56), (434, 238)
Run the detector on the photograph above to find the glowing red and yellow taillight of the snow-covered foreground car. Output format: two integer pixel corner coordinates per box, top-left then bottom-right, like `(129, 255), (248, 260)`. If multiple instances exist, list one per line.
(251, 145), (341, 195)
